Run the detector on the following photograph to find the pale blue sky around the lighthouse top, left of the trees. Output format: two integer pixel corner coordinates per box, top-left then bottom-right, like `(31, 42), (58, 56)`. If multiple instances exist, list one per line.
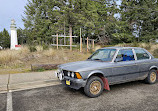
(0, 0), (27, 32)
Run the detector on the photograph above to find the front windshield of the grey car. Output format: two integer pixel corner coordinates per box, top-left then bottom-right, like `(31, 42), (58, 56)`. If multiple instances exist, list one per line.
(88, 49), (116, 61)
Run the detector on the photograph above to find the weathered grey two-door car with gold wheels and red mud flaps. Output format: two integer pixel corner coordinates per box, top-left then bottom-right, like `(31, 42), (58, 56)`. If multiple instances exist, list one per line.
(56, 47), (158, 97)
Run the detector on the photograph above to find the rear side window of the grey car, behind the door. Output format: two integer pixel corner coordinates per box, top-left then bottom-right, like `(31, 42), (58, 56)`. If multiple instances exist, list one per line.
(135, 49), (150, 60)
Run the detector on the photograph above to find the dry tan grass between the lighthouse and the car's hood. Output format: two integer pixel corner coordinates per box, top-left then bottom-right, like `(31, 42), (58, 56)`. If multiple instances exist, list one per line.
(0, 46), (90, 74)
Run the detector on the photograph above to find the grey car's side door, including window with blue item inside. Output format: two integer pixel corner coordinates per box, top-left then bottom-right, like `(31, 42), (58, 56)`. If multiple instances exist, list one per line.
(112, 49), (139, 83)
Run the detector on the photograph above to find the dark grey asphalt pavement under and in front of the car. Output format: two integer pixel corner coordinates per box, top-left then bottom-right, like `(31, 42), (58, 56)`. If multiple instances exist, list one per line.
(0, 81), (158, 111)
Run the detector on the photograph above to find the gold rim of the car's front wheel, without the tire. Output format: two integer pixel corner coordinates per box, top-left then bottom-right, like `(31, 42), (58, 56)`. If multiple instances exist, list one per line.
(90, 81), (101, 95)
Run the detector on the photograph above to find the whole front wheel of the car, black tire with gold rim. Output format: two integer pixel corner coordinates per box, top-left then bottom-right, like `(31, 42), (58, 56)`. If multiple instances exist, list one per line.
(84, 76), (104, 98)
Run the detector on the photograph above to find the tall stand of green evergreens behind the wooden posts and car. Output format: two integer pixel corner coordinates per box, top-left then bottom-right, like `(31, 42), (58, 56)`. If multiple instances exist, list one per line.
(19, 0), (158, 45)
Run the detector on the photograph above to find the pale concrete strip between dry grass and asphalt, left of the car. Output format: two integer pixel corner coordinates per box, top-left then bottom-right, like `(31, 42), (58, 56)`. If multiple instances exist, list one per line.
(0, 70), (60, 93)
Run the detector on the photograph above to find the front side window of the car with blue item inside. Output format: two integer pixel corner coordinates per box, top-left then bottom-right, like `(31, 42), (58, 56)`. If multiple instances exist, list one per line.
(116, 49), (135, 62)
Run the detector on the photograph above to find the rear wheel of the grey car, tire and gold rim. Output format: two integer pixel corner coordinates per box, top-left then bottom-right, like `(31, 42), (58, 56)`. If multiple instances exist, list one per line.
(145, 70), (157, 84)
